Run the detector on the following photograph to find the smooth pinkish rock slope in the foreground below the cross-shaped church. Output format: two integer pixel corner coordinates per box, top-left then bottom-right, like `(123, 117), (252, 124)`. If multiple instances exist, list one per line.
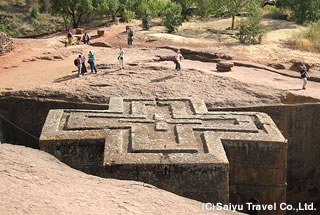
(0, 144), (245, 215)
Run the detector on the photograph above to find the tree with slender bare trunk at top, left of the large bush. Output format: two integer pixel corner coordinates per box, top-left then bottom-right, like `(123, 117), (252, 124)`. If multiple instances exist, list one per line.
(216, 0), (257, 30)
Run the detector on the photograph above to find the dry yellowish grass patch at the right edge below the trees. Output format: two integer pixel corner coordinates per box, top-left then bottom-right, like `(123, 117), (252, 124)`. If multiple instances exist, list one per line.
(287, 21), (320, 53)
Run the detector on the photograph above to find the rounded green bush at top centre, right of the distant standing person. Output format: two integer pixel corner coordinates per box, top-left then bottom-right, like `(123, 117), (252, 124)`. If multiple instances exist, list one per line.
(162, 2), (182, 33)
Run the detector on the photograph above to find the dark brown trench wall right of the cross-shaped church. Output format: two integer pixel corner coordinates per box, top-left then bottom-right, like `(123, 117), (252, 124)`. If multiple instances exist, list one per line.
(208, 104), (320, 214)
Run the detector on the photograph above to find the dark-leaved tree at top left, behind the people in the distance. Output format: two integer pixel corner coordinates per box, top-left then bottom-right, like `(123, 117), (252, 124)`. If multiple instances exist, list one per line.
(51, 0), (94, 28)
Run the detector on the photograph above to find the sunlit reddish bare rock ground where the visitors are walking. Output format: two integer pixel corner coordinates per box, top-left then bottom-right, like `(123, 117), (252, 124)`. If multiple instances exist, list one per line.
(0, 20), (320, 106)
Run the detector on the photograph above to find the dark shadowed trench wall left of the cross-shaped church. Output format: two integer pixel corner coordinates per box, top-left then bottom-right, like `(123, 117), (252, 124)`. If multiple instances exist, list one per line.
(0, 96), (108, 149)
